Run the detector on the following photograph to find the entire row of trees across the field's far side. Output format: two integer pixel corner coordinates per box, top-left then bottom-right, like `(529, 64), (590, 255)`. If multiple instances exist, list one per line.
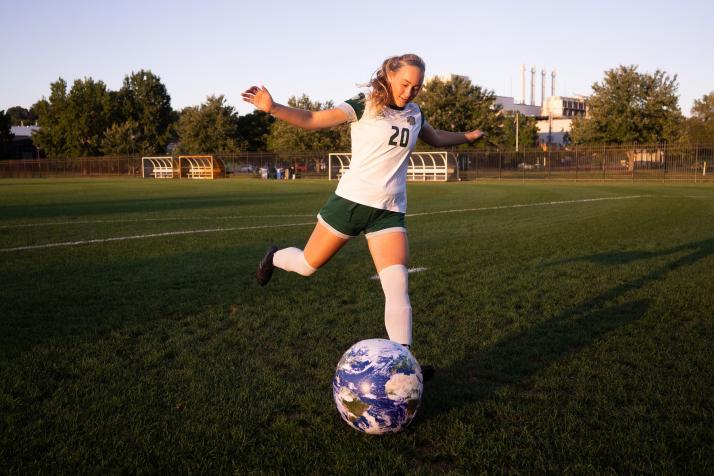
(0, 65), (714, 157)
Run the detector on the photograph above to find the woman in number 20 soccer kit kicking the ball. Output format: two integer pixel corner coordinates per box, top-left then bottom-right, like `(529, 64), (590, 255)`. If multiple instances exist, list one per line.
(242, 54), (483, 360)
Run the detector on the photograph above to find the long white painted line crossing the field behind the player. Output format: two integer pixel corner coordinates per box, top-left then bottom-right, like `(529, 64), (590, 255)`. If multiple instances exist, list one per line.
(0, 195), (650, 253)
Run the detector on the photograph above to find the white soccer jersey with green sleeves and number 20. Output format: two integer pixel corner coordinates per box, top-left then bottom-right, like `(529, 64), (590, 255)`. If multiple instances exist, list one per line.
(335, 94), (424, 213)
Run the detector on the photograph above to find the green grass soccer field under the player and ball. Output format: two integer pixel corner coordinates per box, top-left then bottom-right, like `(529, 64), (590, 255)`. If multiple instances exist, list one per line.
(0, 179), (714, 474)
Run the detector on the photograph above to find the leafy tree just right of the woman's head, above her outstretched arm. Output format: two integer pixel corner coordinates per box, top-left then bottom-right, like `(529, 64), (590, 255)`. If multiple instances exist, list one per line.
(408, 75), (503, 145)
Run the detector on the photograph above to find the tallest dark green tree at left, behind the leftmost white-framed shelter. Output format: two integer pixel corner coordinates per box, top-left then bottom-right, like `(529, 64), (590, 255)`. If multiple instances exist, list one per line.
(111, 69), (174, 155)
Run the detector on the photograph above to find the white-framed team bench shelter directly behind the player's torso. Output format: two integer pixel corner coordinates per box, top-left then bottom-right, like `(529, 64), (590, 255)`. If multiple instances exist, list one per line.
(327, 152), (459, 182)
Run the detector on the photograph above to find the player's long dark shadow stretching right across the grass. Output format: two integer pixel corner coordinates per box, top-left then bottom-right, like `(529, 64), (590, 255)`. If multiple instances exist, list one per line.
(422, 240), (714, 419)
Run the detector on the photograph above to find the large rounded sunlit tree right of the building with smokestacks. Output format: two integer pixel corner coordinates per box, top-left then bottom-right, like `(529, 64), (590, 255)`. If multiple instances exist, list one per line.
(571, 65), (683, 144)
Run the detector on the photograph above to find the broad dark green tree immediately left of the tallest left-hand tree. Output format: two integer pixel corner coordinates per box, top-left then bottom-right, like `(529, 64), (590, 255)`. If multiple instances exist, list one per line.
(33, 78), (111, 157)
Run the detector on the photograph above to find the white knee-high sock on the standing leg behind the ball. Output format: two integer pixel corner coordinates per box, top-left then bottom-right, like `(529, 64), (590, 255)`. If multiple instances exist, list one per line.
(379, 264), (412, 346)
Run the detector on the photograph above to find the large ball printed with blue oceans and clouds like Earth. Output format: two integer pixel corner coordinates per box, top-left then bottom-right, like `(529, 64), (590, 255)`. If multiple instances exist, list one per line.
(332, 339), (423, 435)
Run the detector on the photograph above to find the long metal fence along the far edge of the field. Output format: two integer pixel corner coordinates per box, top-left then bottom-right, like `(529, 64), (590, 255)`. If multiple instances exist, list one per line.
(0, 144), (714, 182)
